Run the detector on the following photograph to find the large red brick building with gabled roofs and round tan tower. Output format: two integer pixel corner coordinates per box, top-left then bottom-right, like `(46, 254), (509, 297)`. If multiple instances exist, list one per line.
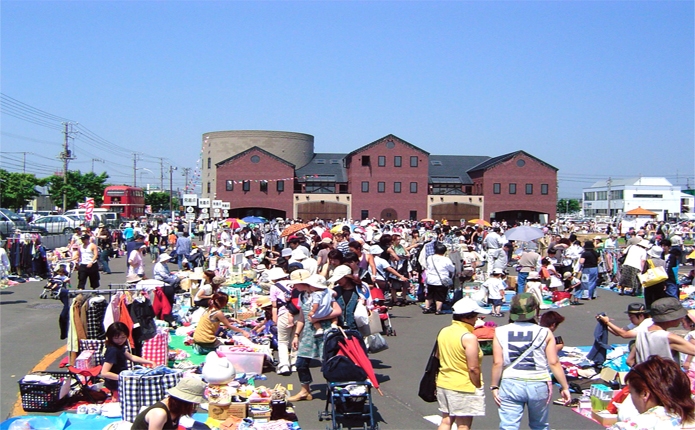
(208, 131), (557, 224)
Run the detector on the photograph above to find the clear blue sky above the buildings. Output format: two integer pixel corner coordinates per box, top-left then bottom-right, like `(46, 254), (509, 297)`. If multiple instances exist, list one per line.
(0, 0), (695, 197)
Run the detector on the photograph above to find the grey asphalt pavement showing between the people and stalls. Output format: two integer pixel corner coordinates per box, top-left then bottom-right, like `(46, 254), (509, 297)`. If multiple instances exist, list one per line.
(0, 252), (684, 429)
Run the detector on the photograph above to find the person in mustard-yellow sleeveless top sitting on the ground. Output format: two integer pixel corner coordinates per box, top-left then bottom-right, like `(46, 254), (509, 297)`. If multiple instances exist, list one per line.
(193, 292), (250, 354)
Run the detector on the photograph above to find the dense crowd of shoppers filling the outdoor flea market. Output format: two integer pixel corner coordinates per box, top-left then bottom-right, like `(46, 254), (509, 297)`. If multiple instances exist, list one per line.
(6, 215), (695, 430)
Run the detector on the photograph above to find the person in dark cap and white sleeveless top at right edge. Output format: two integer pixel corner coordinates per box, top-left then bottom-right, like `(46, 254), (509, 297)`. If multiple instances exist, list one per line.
(626, 297), (695, 366)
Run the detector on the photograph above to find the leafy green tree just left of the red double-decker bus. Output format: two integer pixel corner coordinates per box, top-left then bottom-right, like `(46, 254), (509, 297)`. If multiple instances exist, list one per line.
(46, 170), (109, 209)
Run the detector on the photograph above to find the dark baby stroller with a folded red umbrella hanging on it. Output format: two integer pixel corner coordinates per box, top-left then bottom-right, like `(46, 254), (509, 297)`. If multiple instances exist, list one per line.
(318, 329), (381, 430)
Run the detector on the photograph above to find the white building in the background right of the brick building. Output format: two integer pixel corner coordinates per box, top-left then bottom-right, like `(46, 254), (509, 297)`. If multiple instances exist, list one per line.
(582, 178), (682, 220)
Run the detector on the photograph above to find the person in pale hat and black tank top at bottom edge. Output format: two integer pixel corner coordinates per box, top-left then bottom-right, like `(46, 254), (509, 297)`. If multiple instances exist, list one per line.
(130, 378), (207, 430)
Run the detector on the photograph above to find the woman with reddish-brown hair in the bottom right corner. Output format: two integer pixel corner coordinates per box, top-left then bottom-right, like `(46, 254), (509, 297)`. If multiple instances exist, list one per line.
(609, 355), (695, 430)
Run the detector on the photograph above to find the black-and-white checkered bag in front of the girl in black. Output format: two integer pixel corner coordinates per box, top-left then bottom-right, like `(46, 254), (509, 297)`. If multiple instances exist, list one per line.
(118, 366), (183, 423)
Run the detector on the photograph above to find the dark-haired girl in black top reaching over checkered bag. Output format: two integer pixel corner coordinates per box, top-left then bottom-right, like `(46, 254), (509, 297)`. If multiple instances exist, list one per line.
(99, 322), (155, 401)
